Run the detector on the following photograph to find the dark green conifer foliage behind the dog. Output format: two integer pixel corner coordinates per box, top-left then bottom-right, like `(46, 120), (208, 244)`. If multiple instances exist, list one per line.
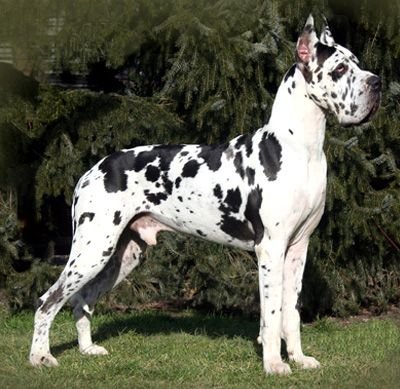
(0, 0), (400, 319)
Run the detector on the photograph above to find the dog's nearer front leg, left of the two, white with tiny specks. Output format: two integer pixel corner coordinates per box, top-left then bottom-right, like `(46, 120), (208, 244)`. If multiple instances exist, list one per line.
(255, 236), (291, 374)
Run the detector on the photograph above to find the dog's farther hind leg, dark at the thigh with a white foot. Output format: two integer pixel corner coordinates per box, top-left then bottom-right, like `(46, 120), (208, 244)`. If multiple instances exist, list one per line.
(71, 229), (146, 355)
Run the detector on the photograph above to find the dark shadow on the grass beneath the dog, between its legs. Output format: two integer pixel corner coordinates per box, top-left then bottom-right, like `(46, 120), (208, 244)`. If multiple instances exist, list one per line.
(52, 311), (261, 356)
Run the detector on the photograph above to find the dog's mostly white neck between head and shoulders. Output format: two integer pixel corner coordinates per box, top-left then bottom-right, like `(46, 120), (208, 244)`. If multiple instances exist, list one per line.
(267, 65), (326, 159)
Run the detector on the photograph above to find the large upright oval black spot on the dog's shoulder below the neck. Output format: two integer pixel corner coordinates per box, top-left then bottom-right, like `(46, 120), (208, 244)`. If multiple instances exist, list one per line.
(259, 133), (282, 181)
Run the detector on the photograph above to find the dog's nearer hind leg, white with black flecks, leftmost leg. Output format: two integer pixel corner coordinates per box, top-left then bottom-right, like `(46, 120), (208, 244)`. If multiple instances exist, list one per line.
(29, 215), (128, 366)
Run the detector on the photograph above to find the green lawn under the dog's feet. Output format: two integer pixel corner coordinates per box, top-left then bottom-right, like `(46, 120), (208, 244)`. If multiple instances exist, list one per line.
(0, 311), (400, 389)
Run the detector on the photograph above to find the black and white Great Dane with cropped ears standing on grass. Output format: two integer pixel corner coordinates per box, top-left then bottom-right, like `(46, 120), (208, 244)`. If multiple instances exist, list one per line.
(30, 16), (380, 374)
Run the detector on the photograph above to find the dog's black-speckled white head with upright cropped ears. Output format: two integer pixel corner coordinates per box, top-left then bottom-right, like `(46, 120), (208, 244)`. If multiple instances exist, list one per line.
(296, 15), (381, 126)
